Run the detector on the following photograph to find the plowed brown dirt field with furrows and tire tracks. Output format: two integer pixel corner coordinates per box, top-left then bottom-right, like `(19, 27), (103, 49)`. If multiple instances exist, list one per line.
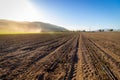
(0, 32), (120, 80)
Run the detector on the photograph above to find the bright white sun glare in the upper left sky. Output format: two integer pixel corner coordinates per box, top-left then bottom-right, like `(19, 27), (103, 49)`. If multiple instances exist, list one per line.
(0, 0), (42, 21)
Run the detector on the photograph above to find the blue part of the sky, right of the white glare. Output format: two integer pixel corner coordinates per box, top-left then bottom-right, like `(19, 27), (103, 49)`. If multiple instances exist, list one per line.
(33, 0), (120, 30)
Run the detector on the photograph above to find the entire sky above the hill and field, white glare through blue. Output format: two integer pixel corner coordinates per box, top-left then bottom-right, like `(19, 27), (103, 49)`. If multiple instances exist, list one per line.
(0, 0), (120, 30)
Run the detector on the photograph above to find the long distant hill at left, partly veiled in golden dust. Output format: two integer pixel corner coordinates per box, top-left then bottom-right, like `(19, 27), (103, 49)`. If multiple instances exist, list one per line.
(0, 20), (67, 33)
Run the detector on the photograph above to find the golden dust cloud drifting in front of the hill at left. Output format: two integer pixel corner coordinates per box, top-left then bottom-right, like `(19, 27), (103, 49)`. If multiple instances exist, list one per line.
(0, 21), (41, 33)
